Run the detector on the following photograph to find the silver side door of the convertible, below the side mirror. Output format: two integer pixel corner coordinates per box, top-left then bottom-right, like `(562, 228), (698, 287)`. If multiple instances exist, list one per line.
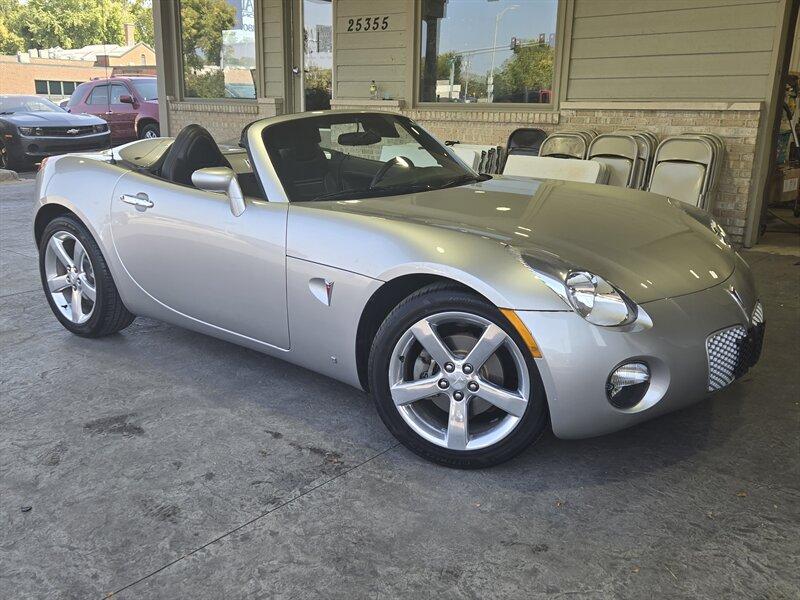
(111, 172), (289, 348)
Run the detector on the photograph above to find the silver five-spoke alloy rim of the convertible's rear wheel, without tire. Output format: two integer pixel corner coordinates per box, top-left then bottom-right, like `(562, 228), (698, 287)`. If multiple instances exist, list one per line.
(44, 231), (97, 325)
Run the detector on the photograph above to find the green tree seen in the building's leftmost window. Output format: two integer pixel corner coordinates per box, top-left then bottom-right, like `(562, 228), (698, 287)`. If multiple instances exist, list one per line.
(181, 0), (236, 69)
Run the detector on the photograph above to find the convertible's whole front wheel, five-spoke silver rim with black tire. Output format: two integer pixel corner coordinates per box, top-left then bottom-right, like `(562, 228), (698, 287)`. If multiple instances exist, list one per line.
(369, 284), (547, 468)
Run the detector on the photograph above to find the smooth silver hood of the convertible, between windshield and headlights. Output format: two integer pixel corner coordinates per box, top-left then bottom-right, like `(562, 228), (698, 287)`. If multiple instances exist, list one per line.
(324, 177), (735, 303)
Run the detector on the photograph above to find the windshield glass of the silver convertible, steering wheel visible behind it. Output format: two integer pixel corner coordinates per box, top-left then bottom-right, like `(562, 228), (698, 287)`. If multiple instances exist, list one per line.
(263, 113), (484, 202)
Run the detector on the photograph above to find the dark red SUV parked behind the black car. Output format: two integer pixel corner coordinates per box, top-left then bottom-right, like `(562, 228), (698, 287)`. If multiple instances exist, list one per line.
(67, 77), (161, 144)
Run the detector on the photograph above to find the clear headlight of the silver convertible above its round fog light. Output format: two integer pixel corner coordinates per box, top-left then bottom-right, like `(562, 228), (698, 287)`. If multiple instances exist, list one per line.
(564, 271), (637, 327)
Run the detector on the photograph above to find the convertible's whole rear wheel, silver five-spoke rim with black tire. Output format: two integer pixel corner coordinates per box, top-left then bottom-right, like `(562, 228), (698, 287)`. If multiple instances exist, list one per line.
(39, 216), (135, 337)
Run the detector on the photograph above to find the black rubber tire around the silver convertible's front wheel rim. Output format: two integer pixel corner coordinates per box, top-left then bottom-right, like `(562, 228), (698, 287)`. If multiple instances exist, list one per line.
(369, 284), (548, 469)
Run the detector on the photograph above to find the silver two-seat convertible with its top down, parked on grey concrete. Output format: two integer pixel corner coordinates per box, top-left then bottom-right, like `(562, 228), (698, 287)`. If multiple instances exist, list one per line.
(34, 111), (764, 468)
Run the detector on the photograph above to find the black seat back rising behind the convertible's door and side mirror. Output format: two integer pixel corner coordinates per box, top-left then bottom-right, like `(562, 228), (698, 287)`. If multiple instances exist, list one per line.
(160, 124), (231, 185)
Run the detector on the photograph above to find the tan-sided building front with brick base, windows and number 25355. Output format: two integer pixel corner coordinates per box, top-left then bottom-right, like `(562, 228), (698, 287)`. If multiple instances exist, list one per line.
(153, 0), (796, 245)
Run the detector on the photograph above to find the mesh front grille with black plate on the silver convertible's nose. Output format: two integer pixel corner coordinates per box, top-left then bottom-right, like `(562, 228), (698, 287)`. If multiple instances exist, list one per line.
(706, 322), (764, 392)
